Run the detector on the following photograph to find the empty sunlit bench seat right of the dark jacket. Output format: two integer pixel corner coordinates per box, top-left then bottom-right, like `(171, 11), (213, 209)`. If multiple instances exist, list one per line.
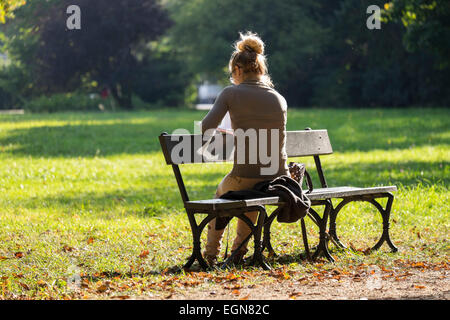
(306, 186), (397, 200)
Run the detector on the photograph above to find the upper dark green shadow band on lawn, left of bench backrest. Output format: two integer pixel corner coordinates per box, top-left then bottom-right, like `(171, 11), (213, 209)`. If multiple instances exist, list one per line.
(0, 123), (179, 158)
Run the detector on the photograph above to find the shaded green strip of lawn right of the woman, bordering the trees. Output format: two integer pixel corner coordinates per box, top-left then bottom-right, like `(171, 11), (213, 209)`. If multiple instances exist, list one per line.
(287, 108), (450, 152)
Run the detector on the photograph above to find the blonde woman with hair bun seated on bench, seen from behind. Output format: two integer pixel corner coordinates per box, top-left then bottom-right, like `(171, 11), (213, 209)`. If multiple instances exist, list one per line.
(202, 32), (289, 265)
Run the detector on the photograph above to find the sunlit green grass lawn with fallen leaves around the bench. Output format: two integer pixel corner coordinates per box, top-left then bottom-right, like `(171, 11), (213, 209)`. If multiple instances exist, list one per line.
(0, 109), (450, 299)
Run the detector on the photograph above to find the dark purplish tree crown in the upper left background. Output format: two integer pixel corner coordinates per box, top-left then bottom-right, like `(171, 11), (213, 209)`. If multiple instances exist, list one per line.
(1, 0), (171, 109)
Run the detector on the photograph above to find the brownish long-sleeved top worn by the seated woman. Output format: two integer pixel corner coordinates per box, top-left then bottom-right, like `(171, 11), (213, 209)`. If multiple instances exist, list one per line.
(202, 80), (289, 179)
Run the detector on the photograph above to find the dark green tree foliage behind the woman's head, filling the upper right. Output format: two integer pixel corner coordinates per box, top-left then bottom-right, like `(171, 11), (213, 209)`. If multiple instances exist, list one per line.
(171, 0), (450, 107)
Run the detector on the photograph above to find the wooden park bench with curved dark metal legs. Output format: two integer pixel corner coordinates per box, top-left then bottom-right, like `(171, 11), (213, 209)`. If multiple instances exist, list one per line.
(159, 128), (397, 269)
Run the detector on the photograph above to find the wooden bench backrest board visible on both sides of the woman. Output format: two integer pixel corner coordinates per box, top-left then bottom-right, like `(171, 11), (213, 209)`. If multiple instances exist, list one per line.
(159, 130), (333, 164)
